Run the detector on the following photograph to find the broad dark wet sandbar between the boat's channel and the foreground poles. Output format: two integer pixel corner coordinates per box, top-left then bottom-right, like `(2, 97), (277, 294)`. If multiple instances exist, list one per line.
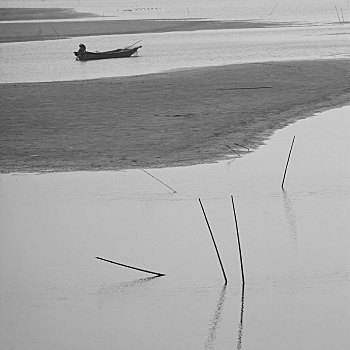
(0, 60), (350, 173)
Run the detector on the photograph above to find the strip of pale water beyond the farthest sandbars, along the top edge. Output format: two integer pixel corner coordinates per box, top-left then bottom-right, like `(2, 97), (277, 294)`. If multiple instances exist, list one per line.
(0, 0), (350, 23)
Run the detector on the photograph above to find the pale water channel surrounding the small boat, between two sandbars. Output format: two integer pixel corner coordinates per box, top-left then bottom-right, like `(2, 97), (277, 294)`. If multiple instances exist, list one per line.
(0, 24), (350, 83)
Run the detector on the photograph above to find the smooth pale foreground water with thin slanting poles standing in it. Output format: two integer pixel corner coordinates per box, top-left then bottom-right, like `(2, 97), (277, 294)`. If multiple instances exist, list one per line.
(0, 107), (350, 350)
